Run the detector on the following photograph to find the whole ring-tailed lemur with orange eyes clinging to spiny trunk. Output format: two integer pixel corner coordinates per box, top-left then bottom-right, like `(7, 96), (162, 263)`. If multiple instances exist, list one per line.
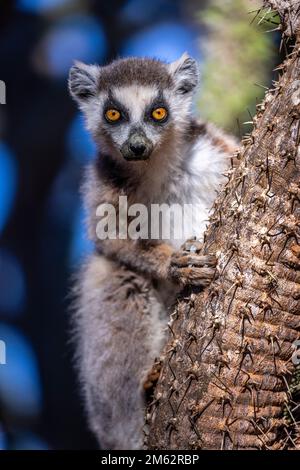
(69, 54), (235, 449)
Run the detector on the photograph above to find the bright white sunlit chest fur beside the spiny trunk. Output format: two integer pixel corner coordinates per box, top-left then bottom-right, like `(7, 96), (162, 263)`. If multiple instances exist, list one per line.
(149, 136), (228, 249)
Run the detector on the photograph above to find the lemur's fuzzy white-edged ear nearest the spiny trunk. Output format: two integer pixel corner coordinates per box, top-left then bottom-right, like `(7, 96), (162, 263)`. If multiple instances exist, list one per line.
(169, 52), (199, 95)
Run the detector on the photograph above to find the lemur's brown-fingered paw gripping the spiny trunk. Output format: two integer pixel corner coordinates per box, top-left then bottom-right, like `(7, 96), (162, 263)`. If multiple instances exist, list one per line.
(169, 240), (217, 287)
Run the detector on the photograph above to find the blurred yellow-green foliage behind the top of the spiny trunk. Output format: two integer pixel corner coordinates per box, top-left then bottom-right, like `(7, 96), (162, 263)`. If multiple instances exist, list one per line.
(199, 0), (276, 133)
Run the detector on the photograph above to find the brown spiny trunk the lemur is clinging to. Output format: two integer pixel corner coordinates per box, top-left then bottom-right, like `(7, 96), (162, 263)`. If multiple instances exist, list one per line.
(146, 0), (300, 449)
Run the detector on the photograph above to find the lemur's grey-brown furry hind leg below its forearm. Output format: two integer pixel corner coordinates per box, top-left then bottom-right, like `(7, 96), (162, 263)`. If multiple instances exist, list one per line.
(77, 255), (165, 450)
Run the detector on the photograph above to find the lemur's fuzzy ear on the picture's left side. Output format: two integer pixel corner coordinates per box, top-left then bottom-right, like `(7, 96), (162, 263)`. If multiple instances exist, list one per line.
(69, 62), (100, 102)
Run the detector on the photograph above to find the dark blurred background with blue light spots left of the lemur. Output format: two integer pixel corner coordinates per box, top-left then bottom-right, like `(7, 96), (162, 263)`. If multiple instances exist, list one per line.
(0, 0), (205, 449)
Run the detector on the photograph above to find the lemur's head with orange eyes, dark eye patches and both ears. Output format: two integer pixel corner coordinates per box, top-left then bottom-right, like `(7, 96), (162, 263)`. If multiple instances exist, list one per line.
(69, 54), (198, 161)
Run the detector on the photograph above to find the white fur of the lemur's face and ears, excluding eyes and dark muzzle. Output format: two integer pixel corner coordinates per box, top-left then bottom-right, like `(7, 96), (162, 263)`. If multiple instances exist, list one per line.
(70, 55), (198, 162)
